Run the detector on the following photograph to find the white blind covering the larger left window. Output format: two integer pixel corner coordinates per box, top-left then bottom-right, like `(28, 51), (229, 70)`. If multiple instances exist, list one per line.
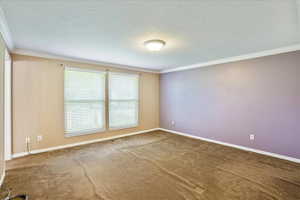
(64, 67), (105, 136)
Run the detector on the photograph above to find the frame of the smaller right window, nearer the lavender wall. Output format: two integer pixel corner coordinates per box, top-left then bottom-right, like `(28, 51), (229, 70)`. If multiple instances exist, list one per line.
(107, 71), (141, 131)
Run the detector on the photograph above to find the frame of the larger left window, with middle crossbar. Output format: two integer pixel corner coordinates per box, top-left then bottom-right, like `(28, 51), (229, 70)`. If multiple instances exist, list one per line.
(63, 66), (107, 138)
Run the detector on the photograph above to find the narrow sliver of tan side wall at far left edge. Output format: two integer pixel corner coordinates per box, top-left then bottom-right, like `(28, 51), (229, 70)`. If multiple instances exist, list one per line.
(0, 34), (5, 182)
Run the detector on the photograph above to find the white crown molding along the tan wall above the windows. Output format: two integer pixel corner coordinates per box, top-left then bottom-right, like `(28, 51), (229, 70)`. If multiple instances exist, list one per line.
(12, 48), (159, 73)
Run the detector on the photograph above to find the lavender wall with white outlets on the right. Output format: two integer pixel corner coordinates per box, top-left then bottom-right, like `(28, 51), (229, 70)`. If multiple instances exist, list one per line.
(160, 51), (300, 159)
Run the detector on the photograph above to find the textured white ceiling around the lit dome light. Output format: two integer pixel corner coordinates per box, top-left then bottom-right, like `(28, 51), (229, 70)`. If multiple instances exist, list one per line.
(0, 0), (299, 70)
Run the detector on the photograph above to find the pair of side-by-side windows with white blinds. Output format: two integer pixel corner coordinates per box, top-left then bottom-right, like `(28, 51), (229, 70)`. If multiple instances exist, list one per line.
(64, 67), (139, 136)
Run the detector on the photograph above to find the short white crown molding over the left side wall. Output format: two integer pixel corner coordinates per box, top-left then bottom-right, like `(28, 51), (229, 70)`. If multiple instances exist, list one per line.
(0, 6), (14, 51)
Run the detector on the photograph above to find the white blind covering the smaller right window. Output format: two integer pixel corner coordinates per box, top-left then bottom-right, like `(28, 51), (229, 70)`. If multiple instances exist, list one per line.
(109, 72), (139, 129)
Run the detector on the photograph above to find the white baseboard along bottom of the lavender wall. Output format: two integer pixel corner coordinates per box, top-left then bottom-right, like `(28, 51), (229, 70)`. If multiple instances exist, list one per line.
(159, 128), (300, 163)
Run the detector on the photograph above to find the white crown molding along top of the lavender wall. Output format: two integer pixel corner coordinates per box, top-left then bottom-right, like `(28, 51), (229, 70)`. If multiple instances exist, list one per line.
(160, 44), (300, 74)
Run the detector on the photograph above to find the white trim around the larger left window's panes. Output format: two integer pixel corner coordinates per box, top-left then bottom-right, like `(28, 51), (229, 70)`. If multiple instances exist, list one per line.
(63, 66), (107, 138)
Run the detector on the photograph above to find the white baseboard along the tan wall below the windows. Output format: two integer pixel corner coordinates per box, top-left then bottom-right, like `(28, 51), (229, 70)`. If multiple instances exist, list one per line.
(12, 128), (160, 158)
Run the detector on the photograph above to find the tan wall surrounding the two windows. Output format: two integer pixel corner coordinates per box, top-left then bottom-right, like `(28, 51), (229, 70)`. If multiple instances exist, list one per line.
(12, 55), (159, 153)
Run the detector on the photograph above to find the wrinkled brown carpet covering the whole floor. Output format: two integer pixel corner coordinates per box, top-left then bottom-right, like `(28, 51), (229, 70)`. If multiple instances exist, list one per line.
(1, 131), (300, 200)
